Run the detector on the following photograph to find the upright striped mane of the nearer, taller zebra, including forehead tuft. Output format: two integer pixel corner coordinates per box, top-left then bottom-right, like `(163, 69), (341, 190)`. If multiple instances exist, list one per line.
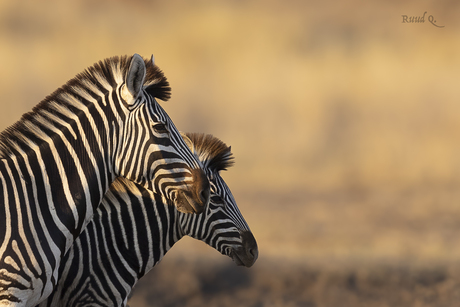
(0, 55), (171, 158)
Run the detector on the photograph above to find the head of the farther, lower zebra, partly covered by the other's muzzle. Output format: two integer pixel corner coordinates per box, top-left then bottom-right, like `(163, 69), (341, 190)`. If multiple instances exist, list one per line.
(179, 133), (259, 267)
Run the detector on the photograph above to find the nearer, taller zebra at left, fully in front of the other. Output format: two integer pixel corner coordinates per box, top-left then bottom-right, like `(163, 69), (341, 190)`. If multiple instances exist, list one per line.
(0, 54), (210, 306)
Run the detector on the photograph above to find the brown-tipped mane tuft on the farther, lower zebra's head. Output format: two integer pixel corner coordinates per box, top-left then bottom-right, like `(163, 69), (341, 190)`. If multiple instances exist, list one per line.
(186, 133), (235, 172)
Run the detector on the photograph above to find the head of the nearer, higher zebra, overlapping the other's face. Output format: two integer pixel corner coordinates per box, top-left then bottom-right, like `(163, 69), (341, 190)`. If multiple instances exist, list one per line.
(115, 54), (209, 213)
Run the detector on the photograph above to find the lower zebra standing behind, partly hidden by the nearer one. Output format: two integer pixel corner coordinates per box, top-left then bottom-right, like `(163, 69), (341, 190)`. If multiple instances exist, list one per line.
(39, 134), (258, 307)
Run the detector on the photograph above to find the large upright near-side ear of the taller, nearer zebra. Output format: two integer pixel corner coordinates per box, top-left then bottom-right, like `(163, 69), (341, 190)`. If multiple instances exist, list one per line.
(123, 53), (146, 102)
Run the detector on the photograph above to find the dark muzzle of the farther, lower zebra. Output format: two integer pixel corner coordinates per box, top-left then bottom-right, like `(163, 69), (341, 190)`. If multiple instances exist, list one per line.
(229, 230), (259, 268)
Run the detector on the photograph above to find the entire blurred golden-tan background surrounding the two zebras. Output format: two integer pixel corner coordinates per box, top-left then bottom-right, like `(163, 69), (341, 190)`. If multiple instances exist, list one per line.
(0, 0), (460, 307)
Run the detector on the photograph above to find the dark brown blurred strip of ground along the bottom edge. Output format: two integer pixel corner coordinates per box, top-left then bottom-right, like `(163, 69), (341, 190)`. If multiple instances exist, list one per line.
(126, 259), (460, 307)
